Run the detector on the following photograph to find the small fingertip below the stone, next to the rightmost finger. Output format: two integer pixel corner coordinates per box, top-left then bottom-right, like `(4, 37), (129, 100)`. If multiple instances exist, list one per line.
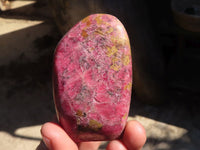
(106, 140), (127, 150)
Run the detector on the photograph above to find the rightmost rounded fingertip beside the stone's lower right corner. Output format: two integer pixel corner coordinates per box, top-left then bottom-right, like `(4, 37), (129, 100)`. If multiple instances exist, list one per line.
(122, 121), (146, 150)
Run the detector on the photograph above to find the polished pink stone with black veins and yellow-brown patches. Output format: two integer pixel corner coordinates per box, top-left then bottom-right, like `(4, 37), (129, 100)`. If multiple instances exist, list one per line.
(53, 14), (132, 142)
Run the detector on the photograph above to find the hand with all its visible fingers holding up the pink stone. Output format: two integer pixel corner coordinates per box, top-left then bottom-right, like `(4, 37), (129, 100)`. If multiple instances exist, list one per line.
(37, 121), (146, 150)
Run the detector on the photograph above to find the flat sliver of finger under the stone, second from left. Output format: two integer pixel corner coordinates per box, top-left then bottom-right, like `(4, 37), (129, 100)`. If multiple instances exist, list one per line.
(79, 141), (101, 150)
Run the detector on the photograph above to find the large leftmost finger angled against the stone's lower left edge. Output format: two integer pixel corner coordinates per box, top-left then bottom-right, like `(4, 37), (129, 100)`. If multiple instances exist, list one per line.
(41, 122), (78, 150)
